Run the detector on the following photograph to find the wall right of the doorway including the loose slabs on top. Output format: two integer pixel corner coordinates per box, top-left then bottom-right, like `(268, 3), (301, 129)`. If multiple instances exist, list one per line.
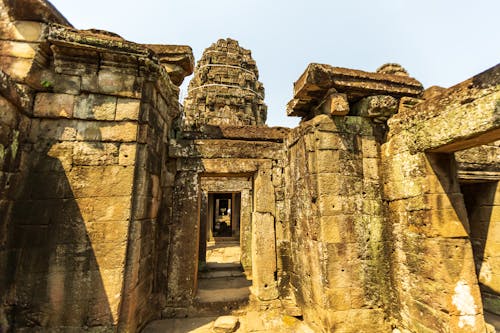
(285, 64), (422, 332)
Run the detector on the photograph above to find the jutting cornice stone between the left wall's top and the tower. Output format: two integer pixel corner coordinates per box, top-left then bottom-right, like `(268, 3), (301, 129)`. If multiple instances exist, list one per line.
(144, 44), (194, 86)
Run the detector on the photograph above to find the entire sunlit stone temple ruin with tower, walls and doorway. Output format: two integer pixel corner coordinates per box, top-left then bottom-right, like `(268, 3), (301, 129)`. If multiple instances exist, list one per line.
(0, 0), (500, 333)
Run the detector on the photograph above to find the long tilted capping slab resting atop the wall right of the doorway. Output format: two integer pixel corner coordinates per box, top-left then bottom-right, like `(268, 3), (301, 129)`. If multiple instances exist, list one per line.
(287, 63), (423, 117)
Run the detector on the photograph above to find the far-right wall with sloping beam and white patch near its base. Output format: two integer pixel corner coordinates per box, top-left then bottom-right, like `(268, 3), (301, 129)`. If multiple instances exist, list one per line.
(382, 66), (500, 332)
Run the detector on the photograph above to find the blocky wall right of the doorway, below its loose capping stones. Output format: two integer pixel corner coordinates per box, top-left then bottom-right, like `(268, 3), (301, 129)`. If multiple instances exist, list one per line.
(286, 115), (391, 332)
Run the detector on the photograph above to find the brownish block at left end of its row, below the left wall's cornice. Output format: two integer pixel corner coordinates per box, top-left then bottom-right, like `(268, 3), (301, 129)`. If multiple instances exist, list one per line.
(33, 93), (75, 118)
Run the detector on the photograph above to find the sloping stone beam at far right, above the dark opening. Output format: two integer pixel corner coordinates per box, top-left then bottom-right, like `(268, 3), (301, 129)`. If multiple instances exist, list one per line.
(388, 64), (500, 153)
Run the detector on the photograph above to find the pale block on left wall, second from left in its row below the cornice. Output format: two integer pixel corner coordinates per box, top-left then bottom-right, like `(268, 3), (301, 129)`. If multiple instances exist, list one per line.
(73, 94), (116, 120)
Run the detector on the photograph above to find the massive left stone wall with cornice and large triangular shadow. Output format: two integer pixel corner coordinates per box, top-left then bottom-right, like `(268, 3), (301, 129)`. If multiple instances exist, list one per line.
(0, 1), (192, 331)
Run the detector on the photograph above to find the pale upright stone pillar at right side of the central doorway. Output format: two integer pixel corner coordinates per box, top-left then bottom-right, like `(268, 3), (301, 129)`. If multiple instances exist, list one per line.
(252, 168), (278, 301)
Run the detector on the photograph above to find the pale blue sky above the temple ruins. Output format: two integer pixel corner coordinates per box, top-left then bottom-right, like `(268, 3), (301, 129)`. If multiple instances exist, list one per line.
(51, 0), (500, 127)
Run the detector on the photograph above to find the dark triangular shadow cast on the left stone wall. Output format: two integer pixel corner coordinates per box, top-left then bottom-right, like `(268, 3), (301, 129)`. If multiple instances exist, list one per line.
(6, 138), (113, 331)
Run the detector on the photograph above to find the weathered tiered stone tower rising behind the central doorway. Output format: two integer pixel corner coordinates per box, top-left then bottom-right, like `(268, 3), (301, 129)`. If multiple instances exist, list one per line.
(184, 38), (267, 129)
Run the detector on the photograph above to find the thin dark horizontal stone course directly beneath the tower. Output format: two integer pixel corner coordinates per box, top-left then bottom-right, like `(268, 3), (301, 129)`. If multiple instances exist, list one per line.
(182, 125), (290, 142)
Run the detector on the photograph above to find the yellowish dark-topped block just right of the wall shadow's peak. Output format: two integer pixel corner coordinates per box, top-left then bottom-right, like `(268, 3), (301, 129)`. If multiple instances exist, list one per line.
(73, 142), (118, 165)
